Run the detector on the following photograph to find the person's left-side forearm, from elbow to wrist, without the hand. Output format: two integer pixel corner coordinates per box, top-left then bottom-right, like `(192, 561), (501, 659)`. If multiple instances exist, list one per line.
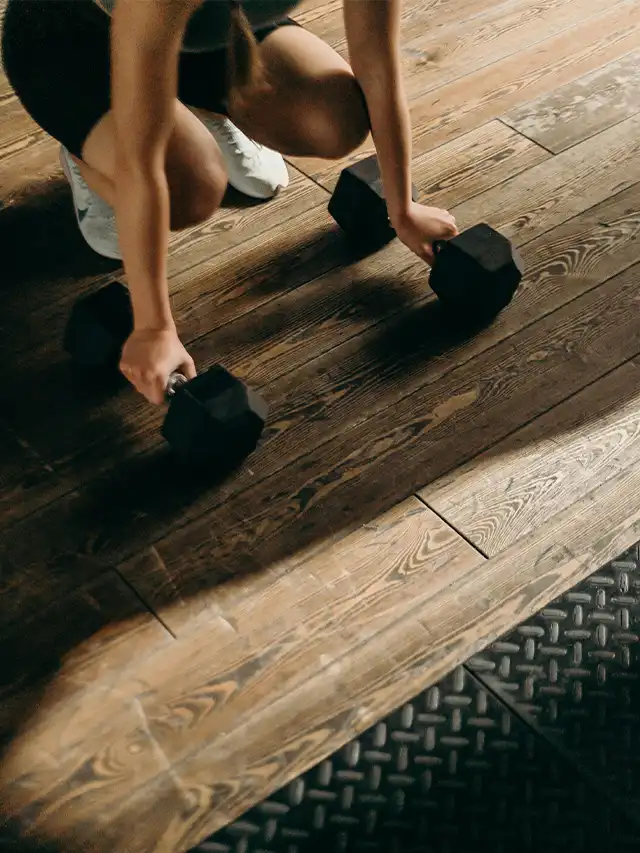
(115, 163), (173, 329)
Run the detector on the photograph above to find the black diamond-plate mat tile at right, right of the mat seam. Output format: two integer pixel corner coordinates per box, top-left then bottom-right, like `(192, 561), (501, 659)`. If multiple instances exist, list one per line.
(469, 545), (640, 818)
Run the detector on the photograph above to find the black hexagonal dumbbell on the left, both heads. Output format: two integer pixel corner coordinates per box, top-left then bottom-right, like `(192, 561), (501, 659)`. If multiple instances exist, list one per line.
(64, 281), (268, 467)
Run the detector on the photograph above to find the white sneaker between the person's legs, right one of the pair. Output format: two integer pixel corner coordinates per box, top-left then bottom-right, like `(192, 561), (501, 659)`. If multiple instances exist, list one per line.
(197, 112), (289, 199)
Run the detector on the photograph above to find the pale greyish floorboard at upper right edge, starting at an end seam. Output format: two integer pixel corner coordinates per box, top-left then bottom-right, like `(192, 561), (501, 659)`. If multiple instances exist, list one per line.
(501, 50), (640, 154)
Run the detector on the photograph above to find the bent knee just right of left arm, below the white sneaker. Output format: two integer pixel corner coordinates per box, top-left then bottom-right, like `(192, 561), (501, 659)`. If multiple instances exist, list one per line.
(169, 162), (227, 231)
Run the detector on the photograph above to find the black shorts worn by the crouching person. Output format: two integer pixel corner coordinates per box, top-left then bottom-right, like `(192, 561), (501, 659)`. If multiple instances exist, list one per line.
(2, 0), (294, 157)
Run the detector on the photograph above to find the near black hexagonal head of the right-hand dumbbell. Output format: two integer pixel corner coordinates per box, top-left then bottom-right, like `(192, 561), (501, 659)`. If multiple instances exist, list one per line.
(429, 223), (524, 320)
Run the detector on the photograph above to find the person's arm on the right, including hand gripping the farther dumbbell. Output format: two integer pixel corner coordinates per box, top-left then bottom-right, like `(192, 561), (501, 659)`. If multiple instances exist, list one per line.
(344, 0), (457, 263)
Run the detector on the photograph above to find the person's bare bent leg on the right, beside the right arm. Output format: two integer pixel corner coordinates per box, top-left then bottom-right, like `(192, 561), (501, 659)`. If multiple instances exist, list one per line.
(229, 26), (370, 159)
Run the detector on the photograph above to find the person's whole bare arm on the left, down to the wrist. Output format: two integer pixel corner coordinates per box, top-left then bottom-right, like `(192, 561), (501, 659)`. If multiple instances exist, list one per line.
(111, 0), (201, 330)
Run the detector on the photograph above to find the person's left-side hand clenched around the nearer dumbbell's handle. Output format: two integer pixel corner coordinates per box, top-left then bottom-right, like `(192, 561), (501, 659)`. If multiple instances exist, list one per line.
(120, 329), (196, 405)
